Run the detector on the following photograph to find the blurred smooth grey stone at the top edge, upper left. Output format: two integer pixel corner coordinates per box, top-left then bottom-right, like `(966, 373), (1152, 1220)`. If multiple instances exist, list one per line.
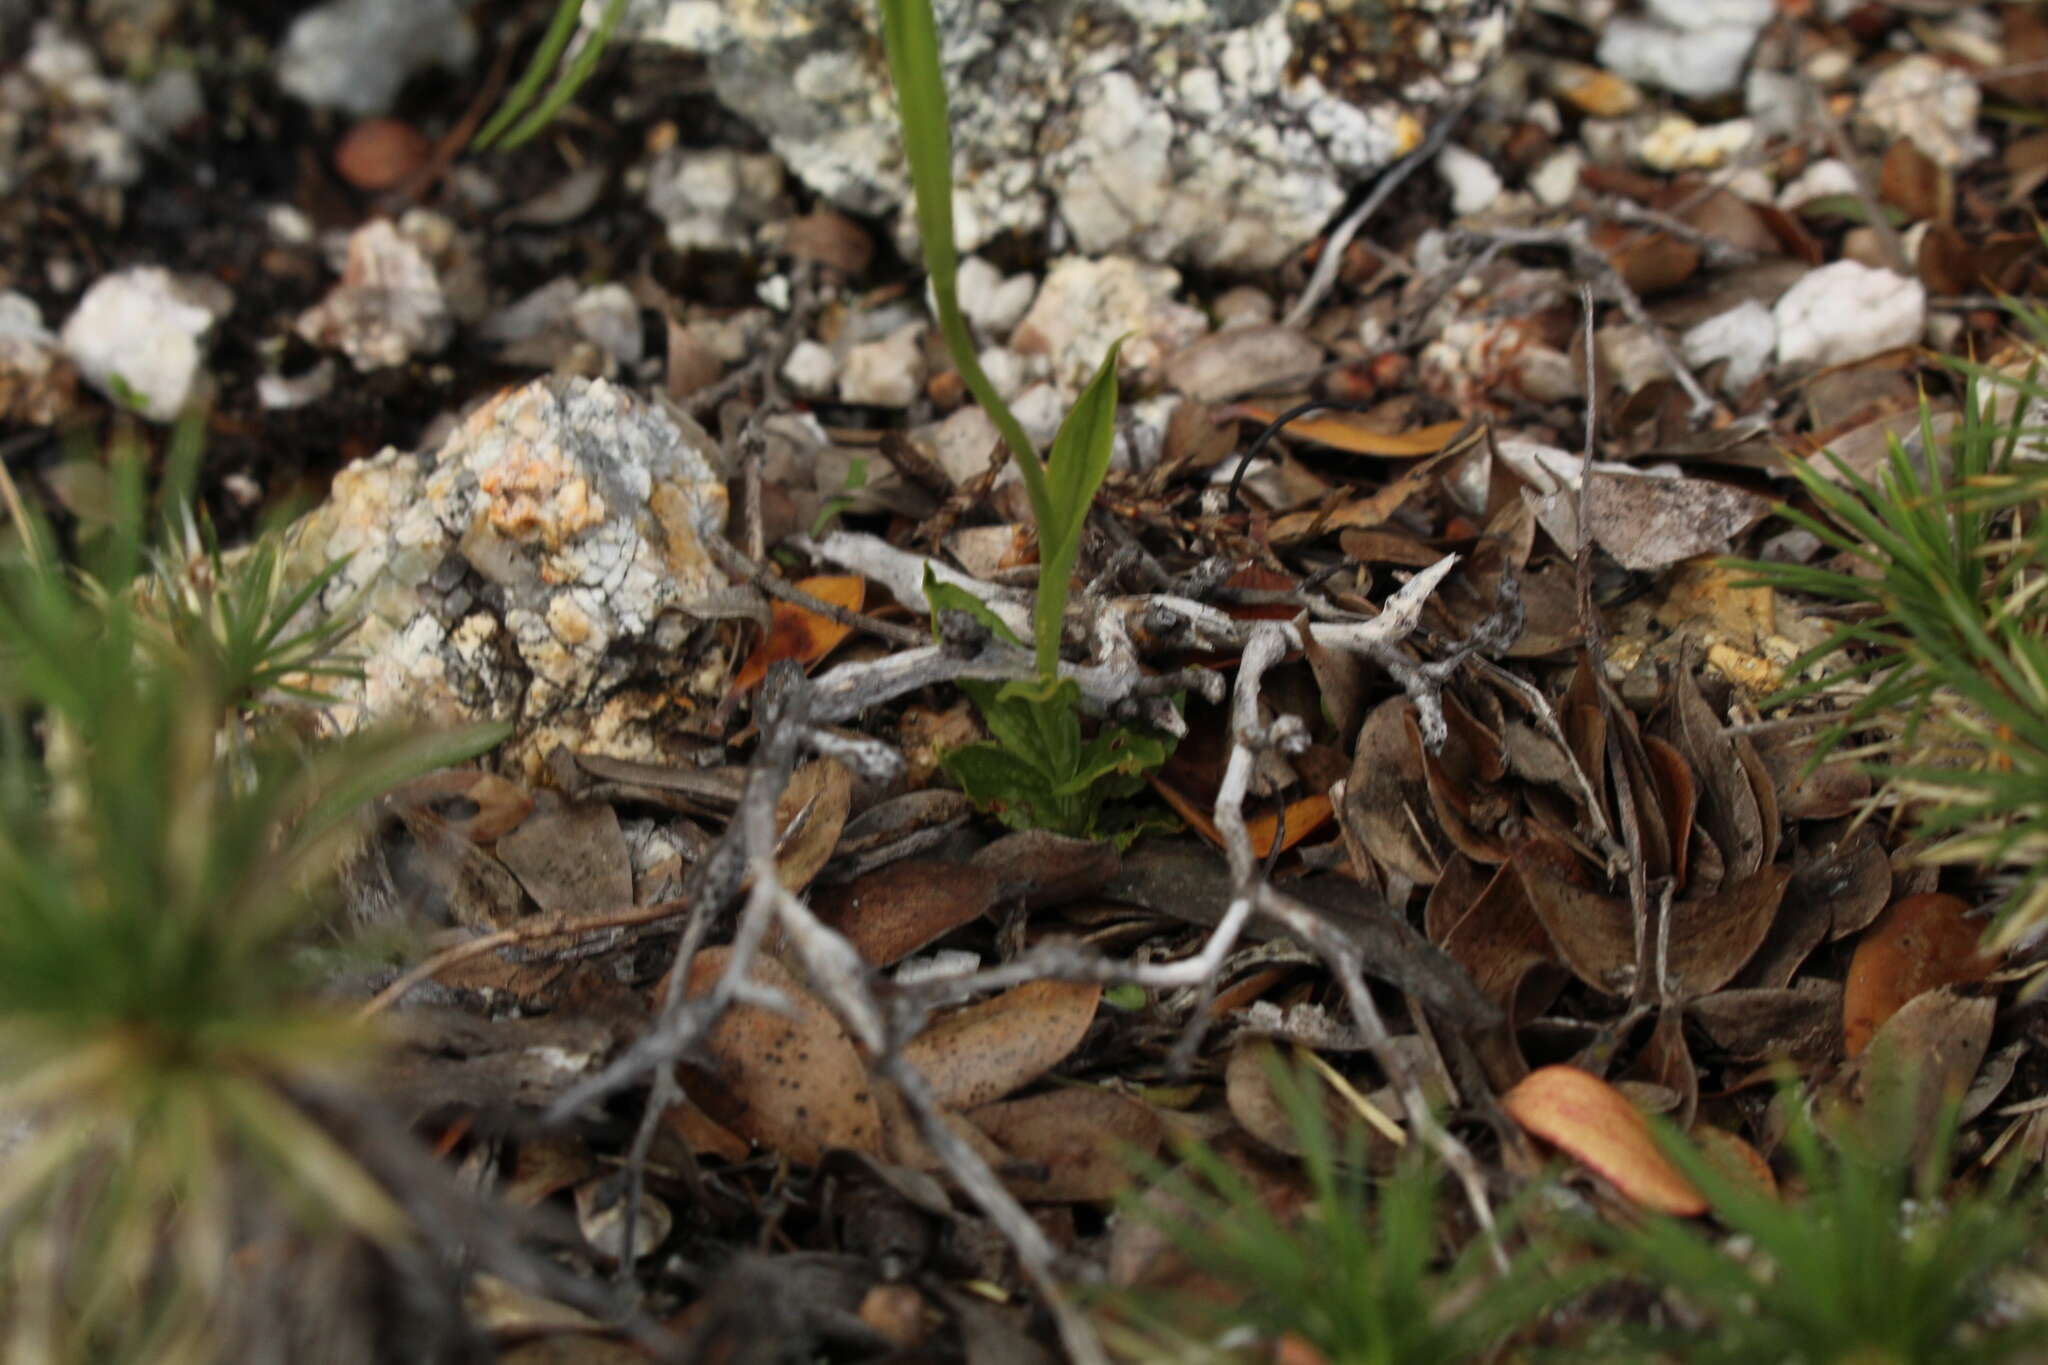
(276, 0), (477, 117)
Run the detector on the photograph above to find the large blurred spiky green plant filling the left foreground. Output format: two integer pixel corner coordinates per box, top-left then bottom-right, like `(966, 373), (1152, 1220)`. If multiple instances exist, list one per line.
(0, 435), (500, 1365)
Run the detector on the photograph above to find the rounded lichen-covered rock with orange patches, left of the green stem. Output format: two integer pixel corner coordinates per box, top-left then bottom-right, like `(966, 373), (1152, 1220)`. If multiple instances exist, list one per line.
(295, 379), (725, 767)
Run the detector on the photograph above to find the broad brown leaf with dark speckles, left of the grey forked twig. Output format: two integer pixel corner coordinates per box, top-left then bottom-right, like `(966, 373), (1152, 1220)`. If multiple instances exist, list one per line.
(684, 948), (883, 1164)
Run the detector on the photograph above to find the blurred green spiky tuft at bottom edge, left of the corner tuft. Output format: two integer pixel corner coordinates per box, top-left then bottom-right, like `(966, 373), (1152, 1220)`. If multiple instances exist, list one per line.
(1104, 1062), (1589, 1365)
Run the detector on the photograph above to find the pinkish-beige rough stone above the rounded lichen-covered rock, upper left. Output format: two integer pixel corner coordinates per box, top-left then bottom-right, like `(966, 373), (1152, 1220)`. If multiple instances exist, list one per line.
(297, 219), (455, 372)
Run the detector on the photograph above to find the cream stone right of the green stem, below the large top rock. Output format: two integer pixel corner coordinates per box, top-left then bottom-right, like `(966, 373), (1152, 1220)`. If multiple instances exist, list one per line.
(1010, 256), (1208, 393)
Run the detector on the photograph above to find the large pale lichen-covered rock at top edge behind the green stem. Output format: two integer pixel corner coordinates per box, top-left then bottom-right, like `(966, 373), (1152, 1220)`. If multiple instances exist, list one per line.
(614, 0), (1522, 270)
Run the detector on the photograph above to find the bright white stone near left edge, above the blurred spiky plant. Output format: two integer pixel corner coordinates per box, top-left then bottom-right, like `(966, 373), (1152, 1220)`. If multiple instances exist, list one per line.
(63, 266), (233, 422)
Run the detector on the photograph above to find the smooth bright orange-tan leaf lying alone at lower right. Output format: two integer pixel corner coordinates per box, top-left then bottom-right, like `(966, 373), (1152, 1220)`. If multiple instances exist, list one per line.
(1501, 1066), (1706, 1218)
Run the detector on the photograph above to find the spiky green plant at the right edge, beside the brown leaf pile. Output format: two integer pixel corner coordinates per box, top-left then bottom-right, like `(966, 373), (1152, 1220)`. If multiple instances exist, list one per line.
(1739, 309), (2048, 945)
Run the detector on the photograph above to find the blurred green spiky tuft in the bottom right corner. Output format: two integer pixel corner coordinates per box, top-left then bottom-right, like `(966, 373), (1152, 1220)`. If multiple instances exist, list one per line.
(1595, 1107), (2048, 1365)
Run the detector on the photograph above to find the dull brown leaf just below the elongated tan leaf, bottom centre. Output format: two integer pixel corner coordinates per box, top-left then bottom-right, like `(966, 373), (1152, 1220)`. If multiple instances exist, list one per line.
(967, 1087), (1165, 1203)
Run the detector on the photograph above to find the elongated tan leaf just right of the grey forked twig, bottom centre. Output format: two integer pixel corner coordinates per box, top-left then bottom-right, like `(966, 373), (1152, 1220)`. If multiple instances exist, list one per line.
(903, 980), (1102, 1109)
